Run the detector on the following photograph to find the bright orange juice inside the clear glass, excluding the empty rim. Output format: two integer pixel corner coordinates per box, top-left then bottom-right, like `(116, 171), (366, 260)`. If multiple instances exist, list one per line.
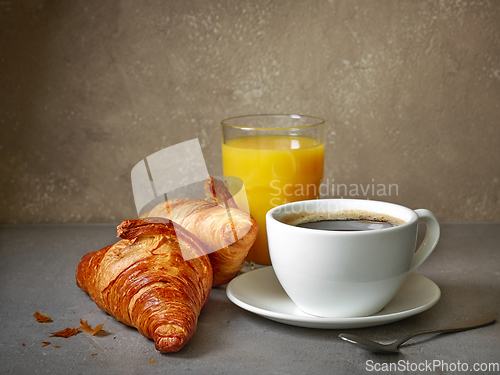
(222, 136), (325, 265)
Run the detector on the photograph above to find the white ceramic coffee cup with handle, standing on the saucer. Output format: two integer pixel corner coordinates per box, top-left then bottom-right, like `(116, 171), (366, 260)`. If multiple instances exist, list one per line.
(266, 199), (440, 318)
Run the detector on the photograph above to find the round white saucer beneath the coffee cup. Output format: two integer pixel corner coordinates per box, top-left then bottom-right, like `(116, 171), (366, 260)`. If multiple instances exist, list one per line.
(226, 267), (441, 329)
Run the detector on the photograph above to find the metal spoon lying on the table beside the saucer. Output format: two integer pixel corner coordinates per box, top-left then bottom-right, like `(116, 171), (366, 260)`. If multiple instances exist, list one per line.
(339, 315), (495, 353)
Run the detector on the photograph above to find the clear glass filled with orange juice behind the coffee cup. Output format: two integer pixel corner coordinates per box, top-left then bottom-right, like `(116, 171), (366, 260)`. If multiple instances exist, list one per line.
(222, 114), (325, 268)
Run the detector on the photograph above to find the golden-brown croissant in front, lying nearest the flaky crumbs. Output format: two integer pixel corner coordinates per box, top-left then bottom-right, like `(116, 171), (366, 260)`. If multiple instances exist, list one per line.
(76, 219), (213, 353)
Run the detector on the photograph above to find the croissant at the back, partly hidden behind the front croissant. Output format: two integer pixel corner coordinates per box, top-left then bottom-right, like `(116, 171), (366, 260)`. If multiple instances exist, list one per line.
(140, 177), (259, 286)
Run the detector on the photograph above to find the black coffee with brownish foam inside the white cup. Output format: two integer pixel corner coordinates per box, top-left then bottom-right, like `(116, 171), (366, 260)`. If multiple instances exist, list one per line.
(281, 210), (405, 231)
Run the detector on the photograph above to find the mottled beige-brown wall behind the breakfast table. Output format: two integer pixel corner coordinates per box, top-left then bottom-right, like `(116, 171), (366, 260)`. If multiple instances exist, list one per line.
(0, 0), (500, 223)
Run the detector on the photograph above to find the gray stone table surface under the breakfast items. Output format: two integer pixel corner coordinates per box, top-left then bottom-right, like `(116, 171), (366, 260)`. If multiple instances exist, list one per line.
(0, 223), (500, 374)
